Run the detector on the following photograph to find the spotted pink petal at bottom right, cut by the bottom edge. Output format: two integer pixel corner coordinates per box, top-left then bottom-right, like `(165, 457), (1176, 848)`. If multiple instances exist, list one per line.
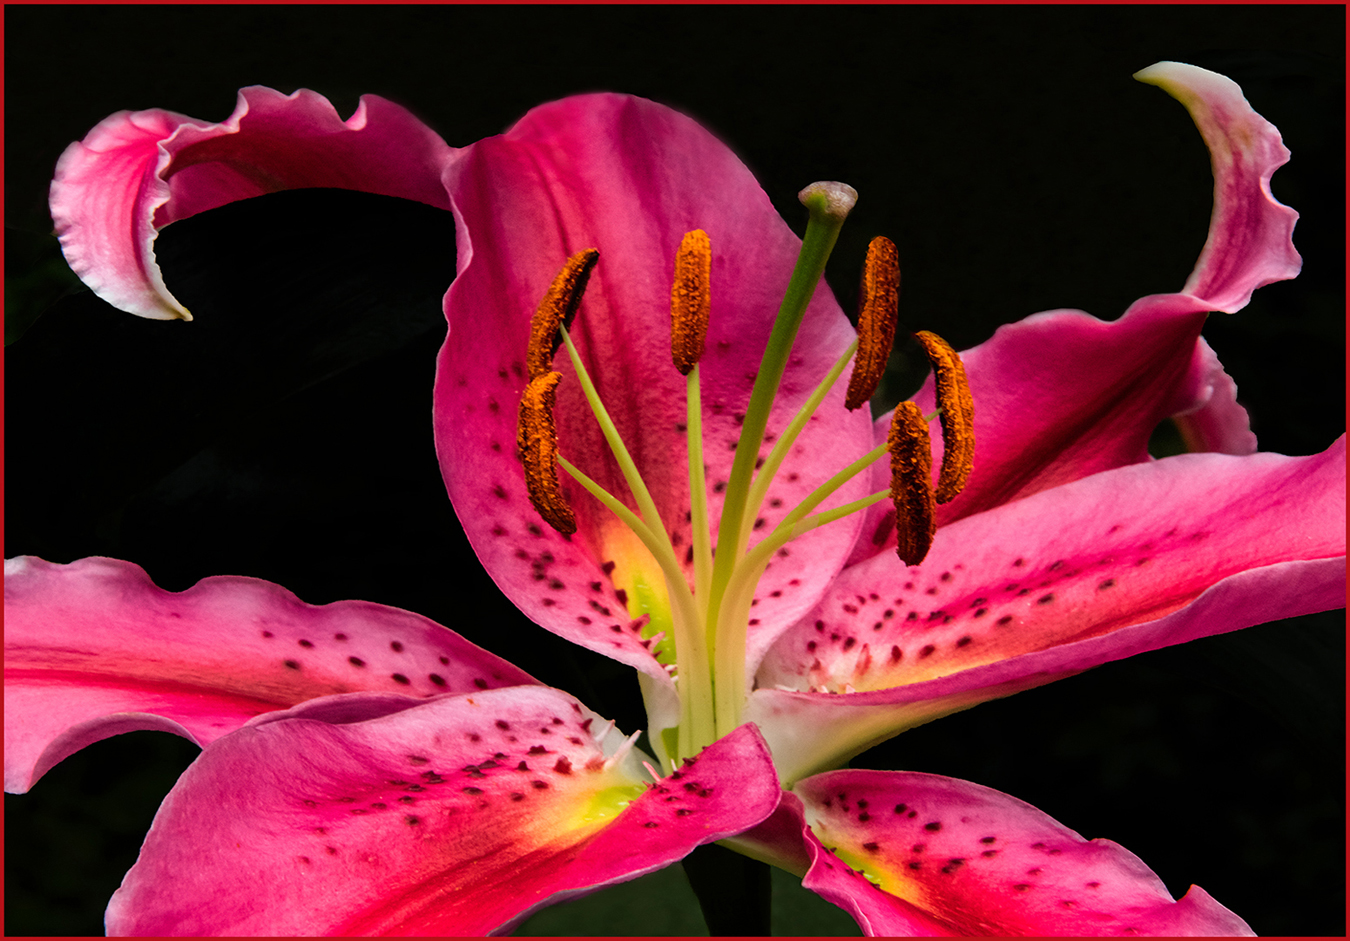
(794, 771), (1253, 937)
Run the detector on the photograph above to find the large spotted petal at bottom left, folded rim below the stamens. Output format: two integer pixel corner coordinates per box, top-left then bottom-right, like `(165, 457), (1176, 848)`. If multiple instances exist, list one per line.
(108, 686), (779, 936)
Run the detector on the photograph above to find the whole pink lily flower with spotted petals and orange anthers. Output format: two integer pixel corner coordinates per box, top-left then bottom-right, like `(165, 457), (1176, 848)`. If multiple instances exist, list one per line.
(5, 63), (1345, 934)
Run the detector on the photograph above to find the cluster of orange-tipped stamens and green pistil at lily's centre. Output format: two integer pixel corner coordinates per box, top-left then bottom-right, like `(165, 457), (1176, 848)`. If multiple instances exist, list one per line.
(517, 184), (975, 767)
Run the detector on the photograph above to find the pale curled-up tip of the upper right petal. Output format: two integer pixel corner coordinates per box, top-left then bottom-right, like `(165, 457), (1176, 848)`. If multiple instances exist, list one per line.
(1134, 62), (1303, 313)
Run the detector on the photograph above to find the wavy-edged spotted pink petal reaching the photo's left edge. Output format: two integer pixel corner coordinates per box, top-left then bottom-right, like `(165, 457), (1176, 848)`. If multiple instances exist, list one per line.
(4, 556), (536, 792)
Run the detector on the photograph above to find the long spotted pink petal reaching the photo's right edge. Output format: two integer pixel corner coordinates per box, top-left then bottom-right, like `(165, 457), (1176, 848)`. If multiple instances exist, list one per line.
(747, 436), (1346, 782)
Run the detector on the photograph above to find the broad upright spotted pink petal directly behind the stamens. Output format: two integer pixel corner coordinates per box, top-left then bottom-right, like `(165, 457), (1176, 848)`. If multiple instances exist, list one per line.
(435, 95), (871, 682)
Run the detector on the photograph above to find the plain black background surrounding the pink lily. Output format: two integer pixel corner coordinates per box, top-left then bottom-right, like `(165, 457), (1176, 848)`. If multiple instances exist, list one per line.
(5, 5), (1345, 936)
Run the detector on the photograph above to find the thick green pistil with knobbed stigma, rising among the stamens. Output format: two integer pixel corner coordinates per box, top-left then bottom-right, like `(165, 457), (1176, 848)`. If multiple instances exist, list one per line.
(699, 192), (846, 744)
